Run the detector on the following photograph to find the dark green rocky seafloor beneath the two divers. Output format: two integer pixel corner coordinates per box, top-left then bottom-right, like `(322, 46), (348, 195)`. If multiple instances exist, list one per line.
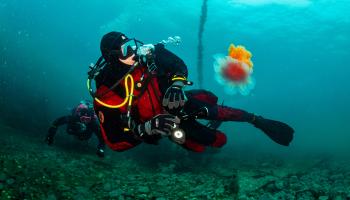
(0, 123), (350, 200)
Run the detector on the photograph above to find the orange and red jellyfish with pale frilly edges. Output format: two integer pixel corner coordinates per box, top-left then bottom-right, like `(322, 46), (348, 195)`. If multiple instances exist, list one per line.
(214, 44), (255, 95)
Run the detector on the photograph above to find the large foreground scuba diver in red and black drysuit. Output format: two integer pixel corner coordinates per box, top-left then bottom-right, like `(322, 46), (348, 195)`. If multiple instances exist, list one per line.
(88, 32), (294, 152)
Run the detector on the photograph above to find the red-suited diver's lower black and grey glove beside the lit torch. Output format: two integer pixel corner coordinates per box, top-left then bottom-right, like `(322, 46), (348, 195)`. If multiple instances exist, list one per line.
(133, 114), (180, 136)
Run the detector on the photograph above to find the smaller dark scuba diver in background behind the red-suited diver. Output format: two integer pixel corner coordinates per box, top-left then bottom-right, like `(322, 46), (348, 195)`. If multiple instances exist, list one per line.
(45, 101), (105, 158)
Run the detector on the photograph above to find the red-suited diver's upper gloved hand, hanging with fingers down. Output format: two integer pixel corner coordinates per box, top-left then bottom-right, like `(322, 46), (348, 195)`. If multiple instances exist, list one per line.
(163, 81), (186, 110)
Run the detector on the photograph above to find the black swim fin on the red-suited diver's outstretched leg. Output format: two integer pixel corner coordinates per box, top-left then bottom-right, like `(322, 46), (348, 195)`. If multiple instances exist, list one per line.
(251, 116), (294, 146)
